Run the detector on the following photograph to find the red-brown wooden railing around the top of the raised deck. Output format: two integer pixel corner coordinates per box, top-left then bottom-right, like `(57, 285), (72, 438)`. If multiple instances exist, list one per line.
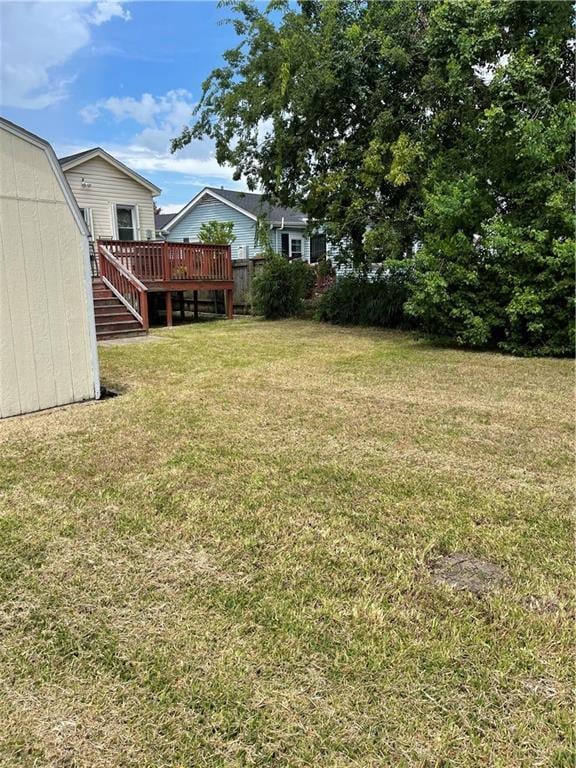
(99, 240), (233, 283)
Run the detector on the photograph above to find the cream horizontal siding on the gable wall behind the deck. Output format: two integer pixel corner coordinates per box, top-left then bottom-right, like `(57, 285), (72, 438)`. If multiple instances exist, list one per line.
(64, 157), (156, 240)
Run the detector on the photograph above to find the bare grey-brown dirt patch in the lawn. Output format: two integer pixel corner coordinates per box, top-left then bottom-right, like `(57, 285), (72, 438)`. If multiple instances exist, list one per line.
(430, 552), (508, 595)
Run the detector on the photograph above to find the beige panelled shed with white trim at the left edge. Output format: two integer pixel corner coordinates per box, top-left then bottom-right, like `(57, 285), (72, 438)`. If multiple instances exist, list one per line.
(0, 118), (100, 417)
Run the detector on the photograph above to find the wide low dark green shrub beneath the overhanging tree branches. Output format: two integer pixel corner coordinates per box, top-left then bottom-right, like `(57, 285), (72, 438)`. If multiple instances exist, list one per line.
(317, 272), (407, 328)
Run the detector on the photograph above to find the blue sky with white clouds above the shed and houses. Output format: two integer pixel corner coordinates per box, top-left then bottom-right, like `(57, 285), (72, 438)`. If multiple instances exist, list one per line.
(0, 0), (258, 212)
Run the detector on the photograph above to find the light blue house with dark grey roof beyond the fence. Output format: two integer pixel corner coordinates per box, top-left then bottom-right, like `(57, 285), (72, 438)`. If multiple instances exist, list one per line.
(163, 187), (326, 263)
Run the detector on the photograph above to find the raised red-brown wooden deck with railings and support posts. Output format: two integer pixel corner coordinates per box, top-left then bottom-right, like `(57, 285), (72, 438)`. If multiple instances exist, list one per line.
(96, 240), (234, 330)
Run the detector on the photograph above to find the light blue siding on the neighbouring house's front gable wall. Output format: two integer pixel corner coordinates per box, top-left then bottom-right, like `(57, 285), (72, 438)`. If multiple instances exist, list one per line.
(167, 196), (258, 259)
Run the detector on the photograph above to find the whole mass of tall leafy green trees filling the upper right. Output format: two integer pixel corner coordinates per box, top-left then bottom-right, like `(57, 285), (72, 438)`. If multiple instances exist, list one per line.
(173, 0), (574, 355)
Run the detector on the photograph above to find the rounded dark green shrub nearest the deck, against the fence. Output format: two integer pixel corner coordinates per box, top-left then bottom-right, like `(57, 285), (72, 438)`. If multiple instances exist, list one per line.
(252, 254), (316, 320)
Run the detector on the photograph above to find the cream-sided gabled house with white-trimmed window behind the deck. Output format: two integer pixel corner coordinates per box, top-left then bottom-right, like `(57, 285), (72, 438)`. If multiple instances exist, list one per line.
(59, 147), (161, 240)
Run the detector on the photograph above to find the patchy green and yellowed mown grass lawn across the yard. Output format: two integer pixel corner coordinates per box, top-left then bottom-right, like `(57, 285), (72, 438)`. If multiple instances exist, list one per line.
(0, 319), (575, 768)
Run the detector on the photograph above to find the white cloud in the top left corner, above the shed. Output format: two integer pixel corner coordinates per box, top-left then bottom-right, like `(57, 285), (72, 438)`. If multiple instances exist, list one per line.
(0, 0), (130, 109)
